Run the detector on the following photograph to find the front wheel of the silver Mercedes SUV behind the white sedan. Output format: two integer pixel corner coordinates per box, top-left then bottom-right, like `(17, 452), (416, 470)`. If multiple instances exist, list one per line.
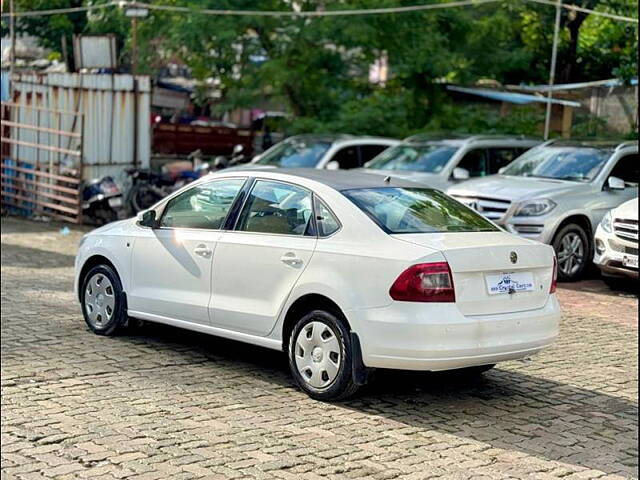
(552, 223), (593, 282)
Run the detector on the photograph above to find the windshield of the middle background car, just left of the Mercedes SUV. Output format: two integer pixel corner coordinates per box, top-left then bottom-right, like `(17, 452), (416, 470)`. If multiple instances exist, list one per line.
(365, 143), (457, 173)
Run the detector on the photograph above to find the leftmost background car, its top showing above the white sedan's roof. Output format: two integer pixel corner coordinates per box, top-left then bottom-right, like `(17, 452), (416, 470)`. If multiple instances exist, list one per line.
(251, 135), (399, 170)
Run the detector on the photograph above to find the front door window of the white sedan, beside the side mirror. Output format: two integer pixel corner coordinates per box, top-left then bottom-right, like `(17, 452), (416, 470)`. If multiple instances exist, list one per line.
(160, 178), (245, 230)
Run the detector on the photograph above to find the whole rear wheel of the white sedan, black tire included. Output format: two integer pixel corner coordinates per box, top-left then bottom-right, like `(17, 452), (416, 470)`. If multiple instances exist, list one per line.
(288, 310), (359, 401)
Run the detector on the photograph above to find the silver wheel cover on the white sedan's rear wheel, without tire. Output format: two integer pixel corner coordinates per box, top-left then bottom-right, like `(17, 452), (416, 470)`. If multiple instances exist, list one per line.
(294, 321), (342, 390)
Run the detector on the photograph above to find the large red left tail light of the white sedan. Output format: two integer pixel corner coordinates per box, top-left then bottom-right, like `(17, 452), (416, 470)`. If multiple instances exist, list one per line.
(389, 262), (456, 302)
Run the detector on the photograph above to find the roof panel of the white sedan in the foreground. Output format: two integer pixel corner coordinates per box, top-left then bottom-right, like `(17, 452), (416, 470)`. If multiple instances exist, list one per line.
(213, 168), (424, 191)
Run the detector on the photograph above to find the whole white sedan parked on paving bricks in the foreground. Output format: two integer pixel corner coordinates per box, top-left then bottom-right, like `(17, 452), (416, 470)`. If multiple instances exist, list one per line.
(76, 169), (560, 400)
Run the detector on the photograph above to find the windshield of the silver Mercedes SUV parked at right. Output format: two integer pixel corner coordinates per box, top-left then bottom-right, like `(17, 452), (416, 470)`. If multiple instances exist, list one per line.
(502, 147), (611, 182)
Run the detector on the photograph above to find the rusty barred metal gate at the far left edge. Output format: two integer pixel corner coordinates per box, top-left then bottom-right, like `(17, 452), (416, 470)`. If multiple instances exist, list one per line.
(0, 98), (84, 223)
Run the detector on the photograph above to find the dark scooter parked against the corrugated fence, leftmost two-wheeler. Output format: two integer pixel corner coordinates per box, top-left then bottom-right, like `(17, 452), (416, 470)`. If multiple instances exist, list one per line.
(82, 176), (124, 225)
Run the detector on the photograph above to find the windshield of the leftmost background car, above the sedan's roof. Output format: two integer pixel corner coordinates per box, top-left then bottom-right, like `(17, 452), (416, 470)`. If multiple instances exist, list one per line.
(256, 138), (331, 168)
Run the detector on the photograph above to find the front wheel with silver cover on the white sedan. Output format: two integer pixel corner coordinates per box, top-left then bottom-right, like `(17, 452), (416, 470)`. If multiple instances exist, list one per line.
(80, 265), (127, 336)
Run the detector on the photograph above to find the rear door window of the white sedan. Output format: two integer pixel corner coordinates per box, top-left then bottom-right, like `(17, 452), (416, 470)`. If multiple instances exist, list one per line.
(236, 180), (313, 236)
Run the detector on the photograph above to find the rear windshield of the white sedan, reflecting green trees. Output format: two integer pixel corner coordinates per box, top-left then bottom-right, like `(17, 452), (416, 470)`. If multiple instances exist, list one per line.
(342, 187), (498, 233)
